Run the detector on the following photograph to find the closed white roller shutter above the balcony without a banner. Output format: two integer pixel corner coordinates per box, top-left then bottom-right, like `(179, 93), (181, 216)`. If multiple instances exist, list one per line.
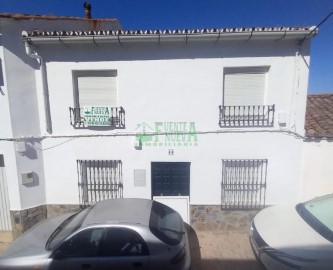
(224, 73), (266, 106)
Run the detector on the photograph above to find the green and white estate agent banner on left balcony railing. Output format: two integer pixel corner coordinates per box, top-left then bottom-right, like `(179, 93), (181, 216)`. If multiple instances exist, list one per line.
(83, 106), (111, 127)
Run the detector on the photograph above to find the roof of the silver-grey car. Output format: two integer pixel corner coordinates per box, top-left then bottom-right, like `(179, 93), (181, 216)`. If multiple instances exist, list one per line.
(82, 198), (153, 227)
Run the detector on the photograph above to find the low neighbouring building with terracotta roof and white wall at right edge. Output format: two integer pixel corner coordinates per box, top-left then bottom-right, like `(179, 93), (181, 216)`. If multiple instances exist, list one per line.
(302, 94), (333, 199)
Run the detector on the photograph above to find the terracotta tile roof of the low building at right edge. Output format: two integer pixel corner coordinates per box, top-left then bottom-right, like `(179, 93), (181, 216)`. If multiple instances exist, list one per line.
(305, 94), (333, 137)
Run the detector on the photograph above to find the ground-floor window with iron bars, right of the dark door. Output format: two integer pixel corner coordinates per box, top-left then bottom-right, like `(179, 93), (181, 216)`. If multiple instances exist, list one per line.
(221, 159), (268, 209)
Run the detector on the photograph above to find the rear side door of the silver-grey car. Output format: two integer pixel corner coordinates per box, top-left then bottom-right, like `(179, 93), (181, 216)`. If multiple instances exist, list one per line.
(99, 227), (150, 270)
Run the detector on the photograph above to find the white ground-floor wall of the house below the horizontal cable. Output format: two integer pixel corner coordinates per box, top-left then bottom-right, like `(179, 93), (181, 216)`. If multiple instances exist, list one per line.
(43, 133), (302, 205)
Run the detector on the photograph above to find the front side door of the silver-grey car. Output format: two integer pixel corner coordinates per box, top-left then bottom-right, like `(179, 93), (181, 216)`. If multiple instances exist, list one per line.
(48, 228), (104, 270)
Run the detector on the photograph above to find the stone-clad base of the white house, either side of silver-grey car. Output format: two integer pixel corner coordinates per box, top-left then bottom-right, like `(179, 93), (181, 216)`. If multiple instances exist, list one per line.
(11, 204), (258, 239)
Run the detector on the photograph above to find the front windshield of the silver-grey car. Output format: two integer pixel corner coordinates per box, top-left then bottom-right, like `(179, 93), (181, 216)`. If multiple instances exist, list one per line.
(46, 207), (91, 250)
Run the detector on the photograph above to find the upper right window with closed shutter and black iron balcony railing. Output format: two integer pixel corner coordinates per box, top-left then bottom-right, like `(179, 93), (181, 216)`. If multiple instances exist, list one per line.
(219, 67), (274, 127)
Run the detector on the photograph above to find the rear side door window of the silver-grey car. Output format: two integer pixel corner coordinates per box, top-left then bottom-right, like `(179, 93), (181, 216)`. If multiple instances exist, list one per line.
(101, 228), (148, 256)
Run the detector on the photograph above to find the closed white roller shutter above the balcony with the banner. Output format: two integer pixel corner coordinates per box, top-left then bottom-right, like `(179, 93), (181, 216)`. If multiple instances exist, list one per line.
(77, 76), (117, 108)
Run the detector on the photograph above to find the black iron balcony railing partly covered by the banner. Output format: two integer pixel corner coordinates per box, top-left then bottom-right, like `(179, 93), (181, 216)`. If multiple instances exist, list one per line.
(69, 107), (125, 128)
